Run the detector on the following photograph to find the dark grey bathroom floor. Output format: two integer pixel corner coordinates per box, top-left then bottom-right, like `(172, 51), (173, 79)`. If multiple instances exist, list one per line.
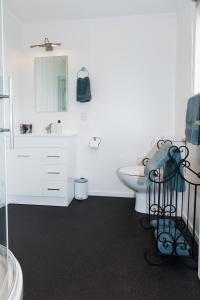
(9, 197), (200, 300)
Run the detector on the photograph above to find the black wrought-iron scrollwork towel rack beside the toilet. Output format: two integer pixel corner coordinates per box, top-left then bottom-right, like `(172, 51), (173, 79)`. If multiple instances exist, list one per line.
(141, 140), (200, 268)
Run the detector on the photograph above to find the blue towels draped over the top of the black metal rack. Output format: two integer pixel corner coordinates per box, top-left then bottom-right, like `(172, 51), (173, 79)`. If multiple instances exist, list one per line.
(145, 143), (185, 192)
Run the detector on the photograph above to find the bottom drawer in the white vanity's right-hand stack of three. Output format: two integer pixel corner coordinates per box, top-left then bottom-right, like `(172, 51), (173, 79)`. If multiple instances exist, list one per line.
(43, 181), (67, 197)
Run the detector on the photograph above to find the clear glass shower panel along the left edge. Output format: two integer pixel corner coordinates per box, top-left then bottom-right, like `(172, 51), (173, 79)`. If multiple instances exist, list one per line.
(0, 0), (8, 300)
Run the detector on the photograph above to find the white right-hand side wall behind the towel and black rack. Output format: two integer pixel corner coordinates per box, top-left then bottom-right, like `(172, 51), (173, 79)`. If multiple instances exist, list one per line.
(175, 0), (200, 278)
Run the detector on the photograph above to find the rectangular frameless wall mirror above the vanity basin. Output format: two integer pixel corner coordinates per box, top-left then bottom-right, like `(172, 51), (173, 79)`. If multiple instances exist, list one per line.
(34, 56), (68, 112)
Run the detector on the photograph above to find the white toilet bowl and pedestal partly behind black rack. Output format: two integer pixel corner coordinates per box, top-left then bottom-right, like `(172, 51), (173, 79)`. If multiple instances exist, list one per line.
(117, 165), (148, 213)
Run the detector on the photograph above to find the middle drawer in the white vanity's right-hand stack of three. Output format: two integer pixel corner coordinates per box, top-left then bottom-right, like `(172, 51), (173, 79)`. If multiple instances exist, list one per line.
(42, 165), (67, 181)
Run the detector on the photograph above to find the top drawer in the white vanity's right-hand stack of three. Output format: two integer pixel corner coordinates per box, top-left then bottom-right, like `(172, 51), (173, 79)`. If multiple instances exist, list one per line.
(41, 148), (67, 165)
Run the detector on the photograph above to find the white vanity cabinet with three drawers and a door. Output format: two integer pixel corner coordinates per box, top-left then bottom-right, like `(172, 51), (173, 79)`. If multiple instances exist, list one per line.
(7, 135), (76, 206)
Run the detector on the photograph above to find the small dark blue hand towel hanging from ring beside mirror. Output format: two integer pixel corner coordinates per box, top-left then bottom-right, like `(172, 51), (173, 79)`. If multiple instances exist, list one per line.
(76, 77), (92, 102)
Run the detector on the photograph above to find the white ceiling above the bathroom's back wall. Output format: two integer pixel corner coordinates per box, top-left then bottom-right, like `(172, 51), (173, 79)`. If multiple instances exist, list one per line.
(4, 0), (180, 22)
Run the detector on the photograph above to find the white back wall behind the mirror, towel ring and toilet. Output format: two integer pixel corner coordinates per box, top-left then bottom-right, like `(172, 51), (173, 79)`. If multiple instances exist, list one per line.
(5, 14), (176, 196)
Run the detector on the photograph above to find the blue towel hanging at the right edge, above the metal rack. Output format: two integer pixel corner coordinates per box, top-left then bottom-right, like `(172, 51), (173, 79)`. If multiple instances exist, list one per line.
(185, 94), (200, 145)
